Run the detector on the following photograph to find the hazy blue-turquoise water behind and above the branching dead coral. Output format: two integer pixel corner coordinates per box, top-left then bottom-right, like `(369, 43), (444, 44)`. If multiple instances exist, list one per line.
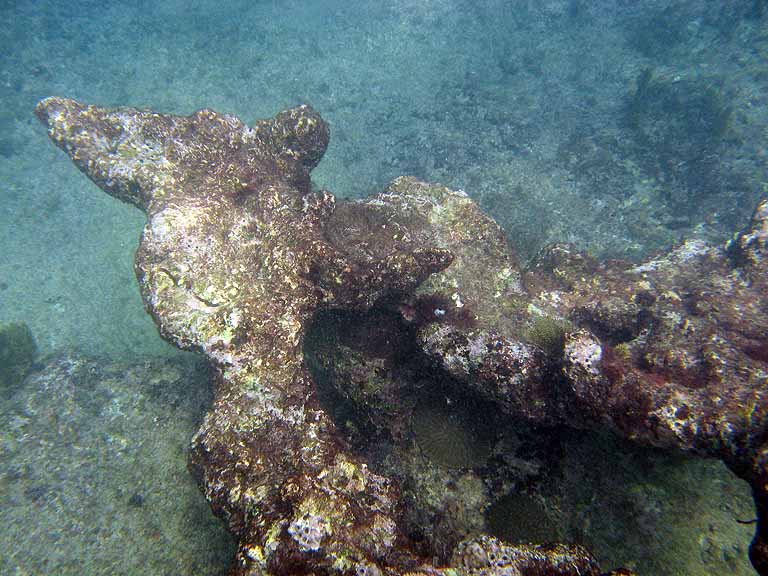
(0, 0), (768, 574)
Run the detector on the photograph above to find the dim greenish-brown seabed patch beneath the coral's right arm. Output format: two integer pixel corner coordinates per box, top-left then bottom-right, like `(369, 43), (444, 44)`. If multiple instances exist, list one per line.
(560, 432), (755, 576)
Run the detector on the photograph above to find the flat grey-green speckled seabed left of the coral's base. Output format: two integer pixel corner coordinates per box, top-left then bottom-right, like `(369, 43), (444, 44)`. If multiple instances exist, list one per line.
(0, 355), (234, 576)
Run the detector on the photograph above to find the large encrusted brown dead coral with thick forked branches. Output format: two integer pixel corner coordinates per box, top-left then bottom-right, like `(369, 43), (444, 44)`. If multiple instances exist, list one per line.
(36, 98), (768, 576)
